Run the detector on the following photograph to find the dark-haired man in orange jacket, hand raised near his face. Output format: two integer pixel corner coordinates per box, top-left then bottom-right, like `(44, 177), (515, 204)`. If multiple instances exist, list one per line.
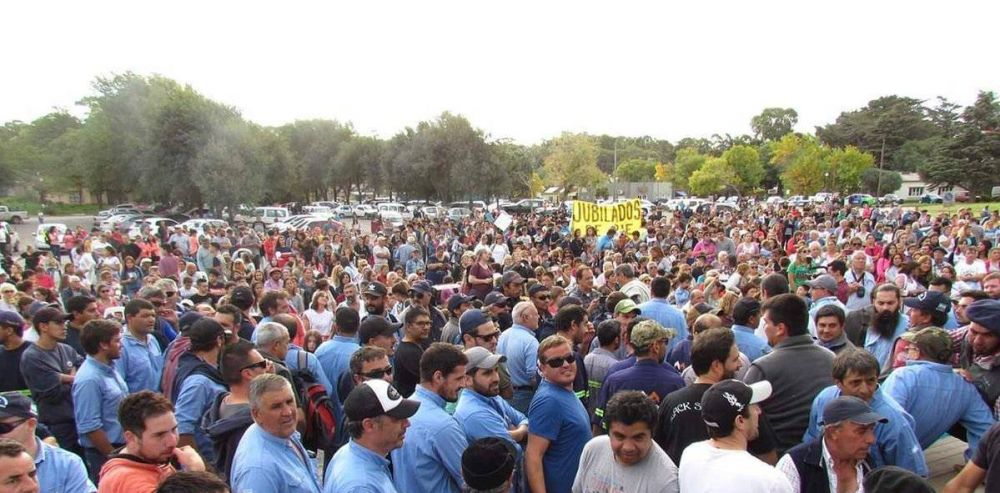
(100, 390), (205, 493)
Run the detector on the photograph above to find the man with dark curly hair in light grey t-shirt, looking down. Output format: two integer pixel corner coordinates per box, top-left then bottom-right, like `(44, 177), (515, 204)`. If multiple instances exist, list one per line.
(573, 391), (678, 493)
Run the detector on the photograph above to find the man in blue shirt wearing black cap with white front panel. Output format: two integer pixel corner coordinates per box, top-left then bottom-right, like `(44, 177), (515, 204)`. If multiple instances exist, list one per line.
(323, 378), (421, 493)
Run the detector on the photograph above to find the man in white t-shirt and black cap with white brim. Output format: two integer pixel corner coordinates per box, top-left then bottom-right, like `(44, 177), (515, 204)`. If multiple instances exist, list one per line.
(679, 380), (793, 493)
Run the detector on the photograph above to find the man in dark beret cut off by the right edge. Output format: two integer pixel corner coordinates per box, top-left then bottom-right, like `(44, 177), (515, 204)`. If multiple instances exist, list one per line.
(959, 299), (1000, 416)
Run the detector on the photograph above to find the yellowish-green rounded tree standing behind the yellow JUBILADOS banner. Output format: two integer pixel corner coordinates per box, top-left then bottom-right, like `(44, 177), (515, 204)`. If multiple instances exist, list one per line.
(544, 133), (606, 200)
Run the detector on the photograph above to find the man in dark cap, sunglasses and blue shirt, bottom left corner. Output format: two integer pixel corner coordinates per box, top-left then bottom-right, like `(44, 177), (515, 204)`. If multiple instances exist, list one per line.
(0, 392), (97, 493)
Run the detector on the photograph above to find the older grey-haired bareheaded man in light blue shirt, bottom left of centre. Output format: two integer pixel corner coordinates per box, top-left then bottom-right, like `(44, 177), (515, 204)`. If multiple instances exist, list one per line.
(232, 373), (320, 493)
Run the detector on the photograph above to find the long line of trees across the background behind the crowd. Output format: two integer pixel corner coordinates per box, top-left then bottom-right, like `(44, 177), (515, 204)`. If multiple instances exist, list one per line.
(0, 73), (1000, 207)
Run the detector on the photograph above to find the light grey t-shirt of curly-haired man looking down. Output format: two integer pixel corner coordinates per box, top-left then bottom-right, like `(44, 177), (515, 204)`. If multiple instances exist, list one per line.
(573, 435), (678, 493)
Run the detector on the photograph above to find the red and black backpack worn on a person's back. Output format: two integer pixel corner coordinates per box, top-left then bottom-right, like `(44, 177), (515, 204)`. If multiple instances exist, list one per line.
(292, 349), (337, 450)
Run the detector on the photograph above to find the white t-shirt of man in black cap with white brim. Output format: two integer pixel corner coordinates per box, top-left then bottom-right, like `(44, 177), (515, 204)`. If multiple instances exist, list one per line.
(678, 440), (792, 493)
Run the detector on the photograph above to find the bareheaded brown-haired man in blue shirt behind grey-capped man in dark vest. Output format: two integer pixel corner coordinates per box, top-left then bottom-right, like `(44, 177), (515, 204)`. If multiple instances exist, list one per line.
(802, 348), (928, 477)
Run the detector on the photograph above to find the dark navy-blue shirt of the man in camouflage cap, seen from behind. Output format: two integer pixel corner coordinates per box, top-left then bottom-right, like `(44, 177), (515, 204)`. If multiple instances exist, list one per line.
(594, 359), (686, 426)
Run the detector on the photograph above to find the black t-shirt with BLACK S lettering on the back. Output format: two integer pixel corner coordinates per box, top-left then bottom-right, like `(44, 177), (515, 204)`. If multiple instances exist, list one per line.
(653, 383), (776, 464)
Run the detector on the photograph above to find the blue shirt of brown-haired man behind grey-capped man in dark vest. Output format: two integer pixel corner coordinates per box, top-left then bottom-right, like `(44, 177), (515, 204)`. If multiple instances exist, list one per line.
(802, 385), (930, 478)
